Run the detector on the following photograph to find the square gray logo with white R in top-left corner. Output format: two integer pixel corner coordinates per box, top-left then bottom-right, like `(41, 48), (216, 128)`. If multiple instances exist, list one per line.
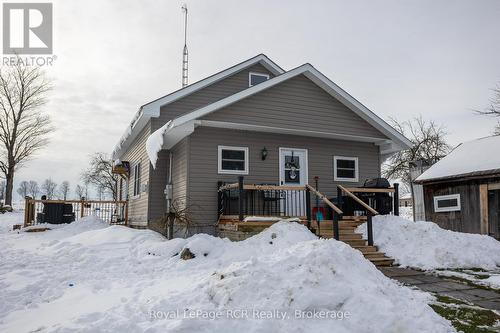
(3, 3), (52, 54)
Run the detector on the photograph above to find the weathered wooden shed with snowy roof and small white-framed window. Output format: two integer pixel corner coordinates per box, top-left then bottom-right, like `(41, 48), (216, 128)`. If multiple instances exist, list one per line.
(415, 136), (500, 239)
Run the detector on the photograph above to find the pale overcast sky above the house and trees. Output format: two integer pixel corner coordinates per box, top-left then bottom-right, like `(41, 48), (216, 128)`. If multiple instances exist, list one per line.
(6, 0), (500, 197)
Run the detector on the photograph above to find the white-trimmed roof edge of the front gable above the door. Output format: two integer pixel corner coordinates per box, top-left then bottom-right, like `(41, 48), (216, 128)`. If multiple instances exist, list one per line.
(147, 63), (411, 163)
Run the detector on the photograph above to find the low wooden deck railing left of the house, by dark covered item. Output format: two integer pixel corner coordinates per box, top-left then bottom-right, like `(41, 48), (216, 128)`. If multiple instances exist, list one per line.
(24, 197), (128, 227)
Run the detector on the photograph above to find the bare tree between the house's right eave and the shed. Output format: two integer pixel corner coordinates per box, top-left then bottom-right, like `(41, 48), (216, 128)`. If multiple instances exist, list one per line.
(382, 116), (451, 185)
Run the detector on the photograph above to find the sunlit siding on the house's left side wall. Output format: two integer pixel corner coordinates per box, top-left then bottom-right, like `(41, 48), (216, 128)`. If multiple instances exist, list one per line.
(121, 119), (151, 224)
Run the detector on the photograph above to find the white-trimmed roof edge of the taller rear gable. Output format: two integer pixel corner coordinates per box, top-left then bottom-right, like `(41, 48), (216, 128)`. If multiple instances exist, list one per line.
(113, 54), (285, 158)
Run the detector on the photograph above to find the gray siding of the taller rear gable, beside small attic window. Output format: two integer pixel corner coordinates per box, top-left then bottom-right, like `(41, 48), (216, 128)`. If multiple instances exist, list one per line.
(152, 64), (273, 131)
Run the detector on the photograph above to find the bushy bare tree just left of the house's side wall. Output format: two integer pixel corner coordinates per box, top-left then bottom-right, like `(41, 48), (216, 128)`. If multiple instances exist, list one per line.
(82, 153), (118, 200)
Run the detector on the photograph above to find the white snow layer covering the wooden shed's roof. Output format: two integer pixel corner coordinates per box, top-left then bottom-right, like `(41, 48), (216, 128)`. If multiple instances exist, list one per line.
(416, 136), (500, 182)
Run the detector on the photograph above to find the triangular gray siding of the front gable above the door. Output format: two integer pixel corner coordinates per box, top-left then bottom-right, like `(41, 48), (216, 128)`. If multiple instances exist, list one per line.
(202, 75), (386, 138)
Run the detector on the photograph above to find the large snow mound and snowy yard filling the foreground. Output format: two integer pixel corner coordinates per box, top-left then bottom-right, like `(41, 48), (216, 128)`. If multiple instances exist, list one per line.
(0, 214), (454, 332)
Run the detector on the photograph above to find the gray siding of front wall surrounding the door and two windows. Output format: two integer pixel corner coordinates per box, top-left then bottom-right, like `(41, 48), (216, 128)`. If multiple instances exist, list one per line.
(189, 127), (380, 232)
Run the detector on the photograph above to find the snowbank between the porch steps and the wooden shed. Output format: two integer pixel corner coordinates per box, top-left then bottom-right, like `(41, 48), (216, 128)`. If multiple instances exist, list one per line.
(358, 216), (500, 270)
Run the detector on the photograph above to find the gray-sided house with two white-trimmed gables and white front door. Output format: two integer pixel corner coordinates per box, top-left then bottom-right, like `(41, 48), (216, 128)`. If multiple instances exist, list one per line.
(113, 54), (410, 233)
